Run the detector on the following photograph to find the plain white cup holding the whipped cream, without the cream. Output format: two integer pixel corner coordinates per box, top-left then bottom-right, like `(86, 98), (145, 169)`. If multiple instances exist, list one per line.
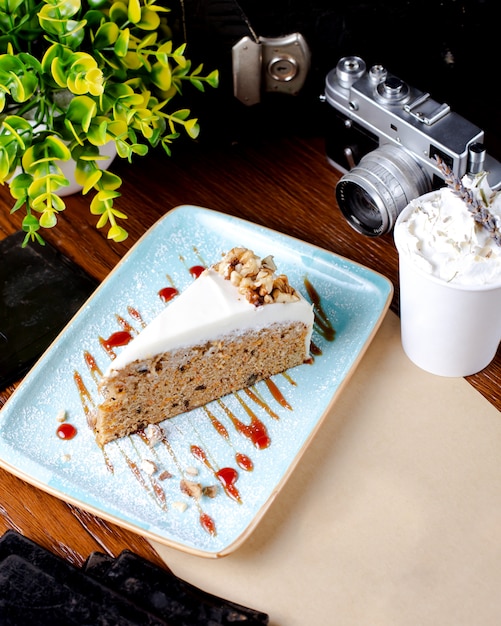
(394, 192), (501, 376)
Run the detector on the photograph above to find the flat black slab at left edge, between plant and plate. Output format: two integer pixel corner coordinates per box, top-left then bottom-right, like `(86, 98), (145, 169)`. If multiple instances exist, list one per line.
(0, 231), (97, 387)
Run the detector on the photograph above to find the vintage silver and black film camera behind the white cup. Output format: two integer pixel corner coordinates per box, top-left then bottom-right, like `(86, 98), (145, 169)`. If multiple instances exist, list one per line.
(323, 56), (501, 237)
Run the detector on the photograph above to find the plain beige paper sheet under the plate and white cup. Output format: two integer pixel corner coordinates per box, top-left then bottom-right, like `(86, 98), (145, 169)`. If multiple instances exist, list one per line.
(149, 312), (501, 626)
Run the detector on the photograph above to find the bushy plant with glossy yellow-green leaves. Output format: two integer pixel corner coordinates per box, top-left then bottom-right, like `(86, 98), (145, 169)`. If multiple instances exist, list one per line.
(0, 0), (218, 245)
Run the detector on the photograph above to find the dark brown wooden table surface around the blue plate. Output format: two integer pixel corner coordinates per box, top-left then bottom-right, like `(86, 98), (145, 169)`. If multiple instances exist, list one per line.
(0, 137), (501, 565)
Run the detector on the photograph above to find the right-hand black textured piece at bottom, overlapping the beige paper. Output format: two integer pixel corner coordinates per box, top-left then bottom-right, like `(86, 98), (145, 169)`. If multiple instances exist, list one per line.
(86, 550), (268, 626)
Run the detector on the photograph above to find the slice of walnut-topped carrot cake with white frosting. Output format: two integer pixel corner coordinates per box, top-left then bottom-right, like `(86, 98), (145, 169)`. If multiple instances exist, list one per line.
(94, 248), (313, 446)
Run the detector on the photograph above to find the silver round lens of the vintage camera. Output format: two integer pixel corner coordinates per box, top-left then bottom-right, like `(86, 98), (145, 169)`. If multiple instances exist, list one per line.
(336, 144), (431, 237)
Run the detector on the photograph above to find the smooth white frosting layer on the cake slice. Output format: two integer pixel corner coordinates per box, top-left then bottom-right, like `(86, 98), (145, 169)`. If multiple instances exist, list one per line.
(105, 268), (313, 376)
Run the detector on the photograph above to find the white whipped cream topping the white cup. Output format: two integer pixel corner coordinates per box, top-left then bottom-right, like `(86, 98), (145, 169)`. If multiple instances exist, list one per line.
(394, 175), (501, 285)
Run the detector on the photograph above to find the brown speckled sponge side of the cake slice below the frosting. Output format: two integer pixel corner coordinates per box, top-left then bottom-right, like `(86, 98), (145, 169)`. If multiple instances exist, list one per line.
(94, 322), (310, 446)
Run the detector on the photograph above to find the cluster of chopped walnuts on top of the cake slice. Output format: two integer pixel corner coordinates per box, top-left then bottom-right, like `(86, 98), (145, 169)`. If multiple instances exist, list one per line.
(214, 248), (299, 306)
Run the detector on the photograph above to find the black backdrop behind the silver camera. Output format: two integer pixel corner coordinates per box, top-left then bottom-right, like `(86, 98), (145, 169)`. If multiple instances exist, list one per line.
(169, 0), (501, 160)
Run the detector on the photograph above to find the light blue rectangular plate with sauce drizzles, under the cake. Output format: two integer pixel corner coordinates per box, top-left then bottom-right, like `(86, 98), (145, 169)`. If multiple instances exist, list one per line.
(0, 206), (393, 558)
